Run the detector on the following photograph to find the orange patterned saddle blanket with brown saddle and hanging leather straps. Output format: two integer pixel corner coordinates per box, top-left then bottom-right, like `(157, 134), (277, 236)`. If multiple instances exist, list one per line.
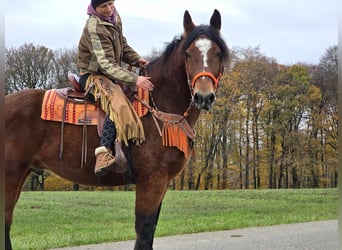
(41, 74), (106, 167)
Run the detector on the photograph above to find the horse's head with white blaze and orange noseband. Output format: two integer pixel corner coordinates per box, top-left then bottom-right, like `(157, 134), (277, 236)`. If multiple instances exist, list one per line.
(183, 10), (229, 110)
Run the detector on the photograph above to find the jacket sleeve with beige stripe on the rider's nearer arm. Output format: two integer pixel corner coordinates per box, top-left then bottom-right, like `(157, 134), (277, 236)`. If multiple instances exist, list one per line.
(88, 16), (138, 85)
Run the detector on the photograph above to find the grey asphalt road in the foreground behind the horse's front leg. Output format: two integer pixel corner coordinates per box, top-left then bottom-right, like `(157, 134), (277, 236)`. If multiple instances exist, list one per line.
(50, 220), (338, 250)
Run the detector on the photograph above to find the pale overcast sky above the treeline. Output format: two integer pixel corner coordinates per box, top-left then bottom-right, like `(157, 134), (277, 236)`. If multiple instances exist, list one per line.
(5, 0), (339, 64)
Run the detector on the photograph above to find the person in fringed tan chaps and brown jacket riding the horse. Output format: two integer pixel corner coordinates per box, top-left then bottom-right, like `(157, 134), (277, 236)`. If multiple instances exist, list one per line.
(78, 0), (154, 176)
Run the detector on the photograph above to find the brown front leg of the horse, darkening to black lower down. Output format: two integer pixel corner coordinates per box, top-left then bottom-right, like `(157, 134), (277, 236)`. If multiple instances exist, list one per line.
(134, 173), (168, 250)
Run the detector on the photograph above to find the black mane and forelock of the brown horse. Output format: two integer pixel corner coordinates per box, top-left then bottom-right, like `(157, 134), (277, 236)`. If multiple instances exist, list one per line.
(151, 25), (229, 64)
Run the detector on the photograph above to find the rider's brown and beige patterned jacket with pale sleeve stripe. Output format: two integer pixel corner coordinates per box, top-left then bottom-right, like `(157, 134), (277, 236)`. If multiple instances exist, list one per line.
(78, 14), (140, 85)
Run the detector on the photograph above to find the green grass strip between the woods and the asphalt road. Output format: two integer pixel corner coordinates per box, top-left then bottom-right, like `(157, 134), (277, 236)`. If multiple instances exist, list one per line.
(11, 189), (338, 250)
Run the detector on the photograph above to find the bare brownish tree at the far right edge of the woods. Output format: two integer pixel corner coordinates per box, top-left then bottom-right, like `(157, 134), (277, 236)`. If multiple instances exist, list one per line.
(310, 46), (338, 187)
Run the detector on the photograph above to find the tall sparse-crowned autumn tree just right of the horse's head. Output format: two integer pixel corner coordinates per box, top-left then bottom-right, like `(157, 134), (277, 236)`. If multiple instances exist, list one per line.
(226, 47), (278, 189)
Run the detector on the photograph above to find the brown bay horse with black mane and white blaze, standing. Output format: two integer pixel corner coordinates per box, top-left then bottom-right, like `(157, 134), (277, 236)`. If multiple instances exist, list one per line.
(5, 10), (230, 250)
